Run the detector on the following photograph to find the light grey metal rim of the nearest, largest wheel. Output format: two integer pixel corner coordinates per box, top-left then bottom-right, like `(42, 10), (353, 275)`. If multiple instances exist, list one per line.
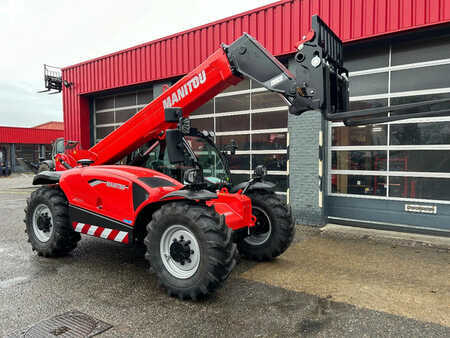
(159, 224), (200, 279)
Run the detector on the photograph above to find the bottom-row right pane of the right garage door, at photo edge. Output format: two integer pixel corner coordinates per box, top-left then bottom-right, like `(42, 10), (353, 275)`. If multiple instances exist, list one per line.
(389, 176), (450, 201)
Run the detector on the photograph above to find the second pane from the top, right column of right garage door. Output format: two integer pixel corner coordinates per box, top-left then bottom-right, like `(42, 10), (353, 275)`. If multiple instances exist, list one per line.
(391, 65), (450, 92)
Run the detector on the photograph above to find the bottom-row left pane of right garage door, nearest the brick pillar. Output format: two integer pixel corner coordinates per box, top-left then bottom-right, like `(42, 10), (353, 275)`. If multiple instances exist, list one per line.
(331, 174), (386, 196)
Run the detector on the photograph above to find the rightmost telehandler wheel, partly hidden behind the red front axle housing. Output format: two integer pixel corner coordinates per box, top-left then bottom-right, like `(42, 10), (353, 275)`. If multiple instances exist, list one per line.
(237, 190), (295, 261)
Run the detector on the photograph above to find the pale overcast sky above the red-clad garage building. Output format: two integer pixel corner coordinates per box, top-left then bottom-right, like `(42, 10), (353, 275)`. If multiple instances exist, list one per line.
(0, 0), (275, 127)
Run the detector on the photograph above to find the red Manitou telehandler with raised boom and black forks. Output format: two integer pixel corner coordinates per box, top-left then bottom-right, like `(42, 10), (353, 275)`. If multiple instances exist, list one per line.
(25, 16), (448, 299)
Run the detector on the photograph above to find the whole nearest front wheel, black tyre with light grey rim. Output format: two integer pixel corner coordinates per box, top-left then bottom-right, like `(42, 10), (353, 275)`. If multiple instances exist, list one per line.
(144, 201), (236, 300)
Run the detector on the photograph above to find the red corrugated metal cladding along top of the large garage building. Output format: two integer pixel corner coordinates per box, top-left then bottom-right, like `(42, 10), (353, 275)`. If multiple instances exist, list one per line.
(63, 0), (450, 147)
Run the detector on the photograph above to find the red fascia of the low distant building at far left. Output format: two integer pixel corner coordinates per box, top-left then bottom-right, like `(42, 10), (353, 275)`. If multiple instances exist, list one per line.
(0, 127), (64, 144)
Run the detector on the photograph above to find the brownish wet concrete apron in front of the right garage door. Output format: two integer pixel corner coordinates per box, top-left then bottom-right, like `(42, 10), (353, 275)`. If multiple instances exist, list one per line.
(240, 232), (450, 326)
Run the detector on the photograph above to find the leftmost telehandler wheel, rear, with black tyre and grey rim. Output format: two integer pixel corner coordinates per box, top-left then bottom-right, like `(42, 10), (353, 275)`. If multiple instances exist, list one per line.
(24, 186), (81, 257)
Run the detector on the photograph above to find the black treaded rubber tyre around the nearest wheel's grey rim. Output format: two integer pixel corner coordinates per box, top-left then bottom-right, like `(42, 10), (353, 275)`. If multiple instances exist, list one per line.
(144, 201), (236, 300)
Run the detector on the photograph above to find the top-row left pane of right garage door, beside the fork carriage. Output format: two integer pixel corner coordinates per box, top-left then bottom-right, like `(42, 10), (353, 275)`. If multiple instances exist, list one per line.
(344, 42), (389, 72)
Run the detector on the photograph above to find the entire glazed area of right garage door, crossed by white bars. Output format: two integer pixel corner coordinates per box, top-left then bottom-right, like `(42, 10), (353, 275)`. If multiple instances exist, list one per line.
(328, 35), (450, 203)
